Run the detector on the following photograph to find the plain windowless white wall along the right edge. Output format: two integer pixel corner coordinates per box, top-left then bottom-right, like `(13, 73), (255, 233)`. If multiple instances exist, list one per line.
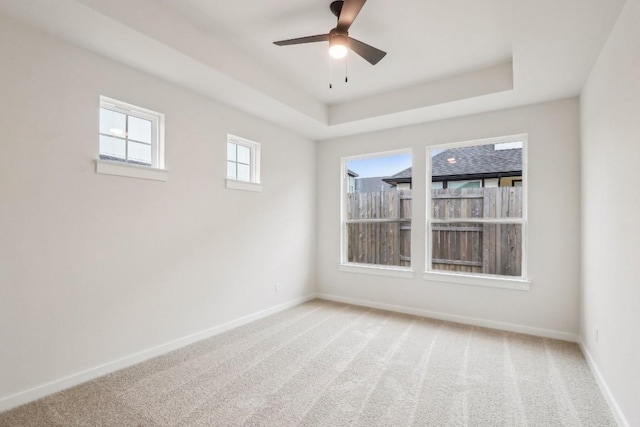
(581, 0), (640, 426)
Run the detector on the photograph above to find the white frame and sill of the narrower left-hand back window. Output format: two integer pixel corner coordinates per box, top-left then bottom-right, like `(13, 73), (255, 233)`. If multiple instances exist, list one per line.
(338, 148), (415, 279)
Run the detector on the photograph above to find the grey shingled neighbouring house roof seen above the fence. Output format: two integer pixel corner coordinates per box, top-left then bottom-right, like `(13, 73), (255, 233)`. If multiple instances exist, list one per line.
(383, 144), (522, 185)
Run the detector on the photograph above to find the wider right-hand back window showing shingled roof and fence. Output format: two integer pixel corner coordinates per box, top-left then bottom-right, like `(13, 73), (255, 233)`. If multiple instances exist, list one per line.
(426, 135), (526, 279)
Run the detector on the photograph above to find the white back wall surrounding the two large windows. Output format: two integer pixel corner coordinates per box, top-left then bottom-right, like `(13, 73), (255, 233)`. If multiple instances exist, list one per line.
(317, 98), (580, 339)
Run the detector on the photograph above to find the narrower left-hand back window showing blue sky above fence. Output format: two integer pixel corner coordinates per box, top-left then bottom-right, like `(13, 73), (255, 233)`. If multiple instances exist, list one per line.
(342, 151), (412, 269)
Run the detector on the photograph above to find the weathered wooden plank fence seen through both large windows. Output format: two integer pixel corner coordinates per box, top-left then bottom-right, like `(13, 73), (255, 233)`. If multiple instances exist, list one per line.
(347, 187), (522, 276)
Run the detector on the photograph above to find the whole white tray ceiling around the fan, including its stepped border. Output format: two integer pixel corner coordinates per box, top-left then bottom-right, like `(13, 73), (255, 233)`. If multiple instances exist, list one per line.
(0, 0), (624, 140)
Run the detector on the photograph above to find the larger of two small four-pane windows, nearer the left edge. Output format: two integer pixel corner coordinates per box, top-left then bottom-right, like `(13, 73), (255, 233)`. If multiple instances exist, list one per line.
(99, 97), (164, 169)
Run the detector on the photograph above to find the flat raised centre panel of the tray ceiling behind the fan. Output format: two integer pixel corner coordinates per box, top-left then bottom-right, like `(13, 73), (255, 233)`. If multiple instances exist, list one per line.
(158, 0), (512, 104)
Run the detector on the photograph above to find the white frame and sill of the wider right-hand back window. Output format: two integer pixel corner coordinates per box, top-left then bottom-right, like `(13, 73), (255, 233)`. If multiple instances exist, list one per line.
(423, 134), (531, 290)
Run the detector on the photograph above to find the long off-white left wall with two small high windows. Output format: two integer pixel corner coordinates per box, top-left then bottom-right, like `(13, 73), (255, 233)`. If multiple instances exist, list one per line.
(0, 18), (316, 403)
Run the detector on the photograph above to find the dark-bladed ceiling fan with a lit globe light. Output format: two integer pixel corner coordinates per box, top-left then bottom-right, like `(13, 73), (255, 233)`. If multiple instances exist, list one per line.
(273, 0), (387, 65)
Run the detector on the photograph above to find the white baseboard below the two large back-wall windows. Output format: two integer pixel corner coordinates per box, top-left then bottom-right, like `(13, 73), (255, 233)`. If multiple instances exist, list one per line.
(318, 294), (579, 343)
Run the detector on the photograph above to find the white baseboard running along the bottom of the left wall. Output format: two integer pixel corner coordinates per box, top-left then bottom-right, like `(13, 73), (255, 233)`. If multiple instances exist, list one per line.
(0, 295), (316, 412)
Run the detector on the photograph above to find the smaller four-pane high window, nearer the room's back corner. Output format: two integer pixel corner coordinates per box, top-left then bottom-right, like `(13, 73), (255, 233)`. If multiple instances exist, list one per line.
(227, 135), (260, 191)
